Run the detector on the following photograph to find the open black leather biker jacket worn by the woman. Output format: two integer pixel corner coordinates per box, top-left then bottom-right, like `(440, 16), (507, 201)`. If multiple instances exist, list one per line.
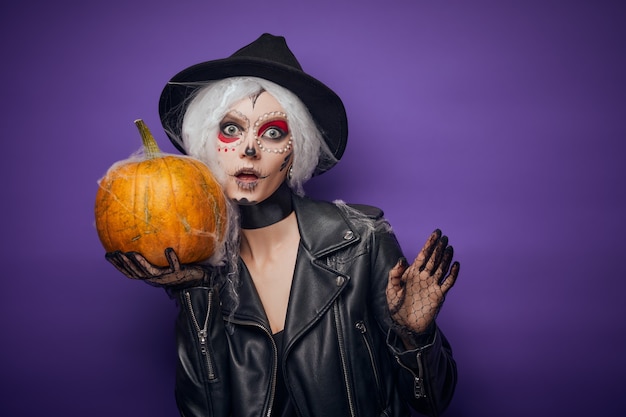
(171, 197), (456, 417)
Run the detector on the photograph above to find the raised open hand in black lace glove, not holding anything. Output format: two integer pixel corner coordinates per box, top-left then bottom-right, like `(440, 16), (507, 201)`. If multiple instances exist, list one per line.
(387, 229), (460, 343)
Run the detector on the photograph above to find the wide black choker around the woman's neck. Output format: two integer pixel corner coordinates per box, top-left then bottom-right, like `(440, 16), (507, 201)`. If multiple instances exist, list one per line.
(239, 182), (293, 229)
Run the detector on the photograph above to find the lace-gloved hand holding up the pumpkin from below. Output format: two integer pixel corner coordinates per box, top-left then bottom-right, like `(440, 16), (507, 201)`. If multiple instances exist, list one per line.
(105, 248), (210, 286)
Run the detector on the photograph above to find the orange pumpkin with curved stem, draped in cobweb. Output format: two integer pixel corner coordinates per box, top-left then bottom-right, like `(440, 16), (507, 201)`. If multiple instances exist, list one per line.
(95, 120), (227, 266)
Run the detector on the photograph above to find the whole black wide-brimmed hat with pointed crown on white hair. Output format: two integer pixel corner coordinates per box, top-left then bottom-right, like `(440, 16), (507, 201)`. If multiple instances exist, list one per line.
(159, 33), (348, 175)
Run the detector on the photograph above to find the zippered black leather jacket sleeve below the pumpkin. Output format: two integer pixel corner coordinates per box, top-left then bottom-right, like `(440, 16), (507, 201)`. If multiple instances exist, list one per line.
(173, 286), (230, 417)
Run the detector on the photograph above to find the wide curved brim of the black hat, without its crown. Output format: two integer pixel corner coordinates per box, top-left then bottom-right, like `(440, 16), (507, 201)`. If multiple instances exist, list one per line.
(159, 57), (348, 175)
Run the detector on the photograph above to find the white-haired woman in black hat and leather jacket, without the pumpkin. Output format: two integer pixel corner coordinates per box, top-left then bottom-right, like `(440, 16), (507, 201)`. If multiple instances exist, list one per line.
(107, 34), (459, 416)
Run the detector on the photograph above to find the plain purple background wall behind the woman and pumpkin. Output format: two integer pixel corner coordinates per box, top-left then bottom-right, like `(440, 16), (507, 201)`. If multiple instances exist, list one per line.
(0, 0), (626, 417)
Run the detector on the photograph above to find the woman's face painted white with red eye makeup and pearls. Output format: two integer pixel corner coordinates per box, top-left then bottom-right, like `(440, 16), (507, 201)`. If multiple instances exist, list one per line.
(216, 92), (293, 204)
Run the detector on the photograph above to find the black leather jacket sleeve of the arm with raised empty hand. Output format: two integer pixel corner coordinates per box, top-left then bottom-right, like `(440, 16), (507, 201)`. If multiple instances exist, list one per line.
(372, 219), (457, 417)
